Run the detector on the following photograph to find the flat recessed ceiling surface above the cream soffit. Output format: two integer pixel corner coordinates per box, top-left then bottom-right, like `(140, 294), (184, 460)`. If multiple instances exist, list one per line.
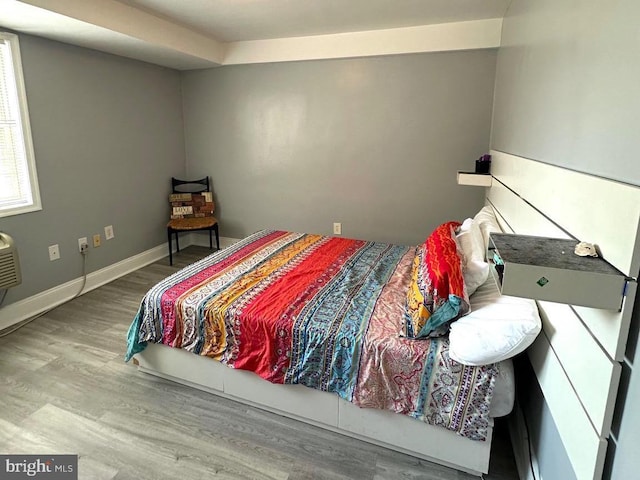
(123, 0), (509, 42)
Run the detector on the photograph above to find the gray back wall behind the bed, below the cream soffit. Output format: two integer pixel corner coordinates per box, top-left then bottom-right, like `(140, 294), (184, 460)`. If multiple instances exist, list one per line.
(183, 50), (496, 244)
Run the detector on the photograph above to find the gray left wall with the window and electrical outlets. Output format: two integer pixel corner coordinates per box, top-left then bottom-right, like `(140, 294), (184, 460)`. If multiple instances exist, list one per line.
(0, 35), (185, 306)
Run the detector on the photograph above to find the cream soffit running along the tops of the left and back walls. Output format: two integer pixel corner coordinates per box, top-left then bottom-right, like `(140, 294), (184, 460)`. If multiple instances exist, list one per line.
(7, 0), (502, 70)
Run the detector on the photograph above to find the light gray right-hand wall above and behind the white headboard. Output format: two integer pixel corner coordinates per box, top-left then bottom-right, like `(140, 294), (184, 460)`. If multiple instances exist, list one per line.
(491, 0), (640, 479)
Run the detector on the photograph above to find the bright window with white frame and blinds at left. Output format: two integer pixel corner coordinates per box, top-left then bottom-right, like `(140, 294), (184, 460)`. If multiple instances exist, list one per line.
(0, 32), (41, 217)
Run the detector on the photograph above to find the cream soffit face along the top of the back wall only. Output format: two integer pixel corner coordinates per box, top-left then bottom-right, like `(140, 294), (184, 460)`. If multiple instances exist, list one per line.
(222, 18), (502, 65)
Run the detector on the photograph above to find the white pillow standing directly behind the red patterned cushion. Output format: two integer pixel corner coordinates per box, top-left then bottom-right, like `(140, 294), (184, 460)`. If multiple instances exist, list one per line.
(456, 218), (489, 295)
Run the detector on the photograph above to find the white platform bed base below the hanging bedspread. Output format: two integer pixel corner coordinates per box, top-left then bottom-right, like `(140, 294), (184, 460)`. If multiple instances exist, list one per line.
(134, 344), (493, 476)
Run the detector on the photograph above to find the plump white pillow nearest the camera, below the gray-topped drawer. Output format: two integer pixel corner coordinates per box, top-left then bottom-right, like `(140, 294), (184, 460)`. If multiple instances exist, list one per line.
(449, 275), (542, 365)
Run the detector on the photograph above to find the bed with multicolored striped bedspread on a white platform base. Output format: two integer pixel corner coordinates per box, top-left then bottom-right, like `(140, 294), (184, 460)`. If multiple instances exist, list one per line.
(127, 224), (539, 475)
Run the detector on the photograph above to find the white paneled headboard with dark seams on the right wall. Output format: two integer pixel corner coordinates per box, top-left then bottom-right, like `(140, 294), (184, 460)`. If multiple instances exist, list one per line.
(487, 151), (640, 479)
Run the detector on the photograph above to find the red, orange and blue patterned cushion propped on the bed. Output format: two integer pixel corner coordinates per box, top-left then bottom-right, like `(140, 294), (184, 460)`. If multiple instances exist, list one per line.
(402, 222), (469, 338)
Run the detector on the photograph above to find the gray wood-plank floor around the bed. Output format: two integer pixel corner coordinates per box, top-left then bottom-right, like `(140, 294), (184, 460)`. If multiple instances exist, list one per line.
(0, 247), (518, 480)
